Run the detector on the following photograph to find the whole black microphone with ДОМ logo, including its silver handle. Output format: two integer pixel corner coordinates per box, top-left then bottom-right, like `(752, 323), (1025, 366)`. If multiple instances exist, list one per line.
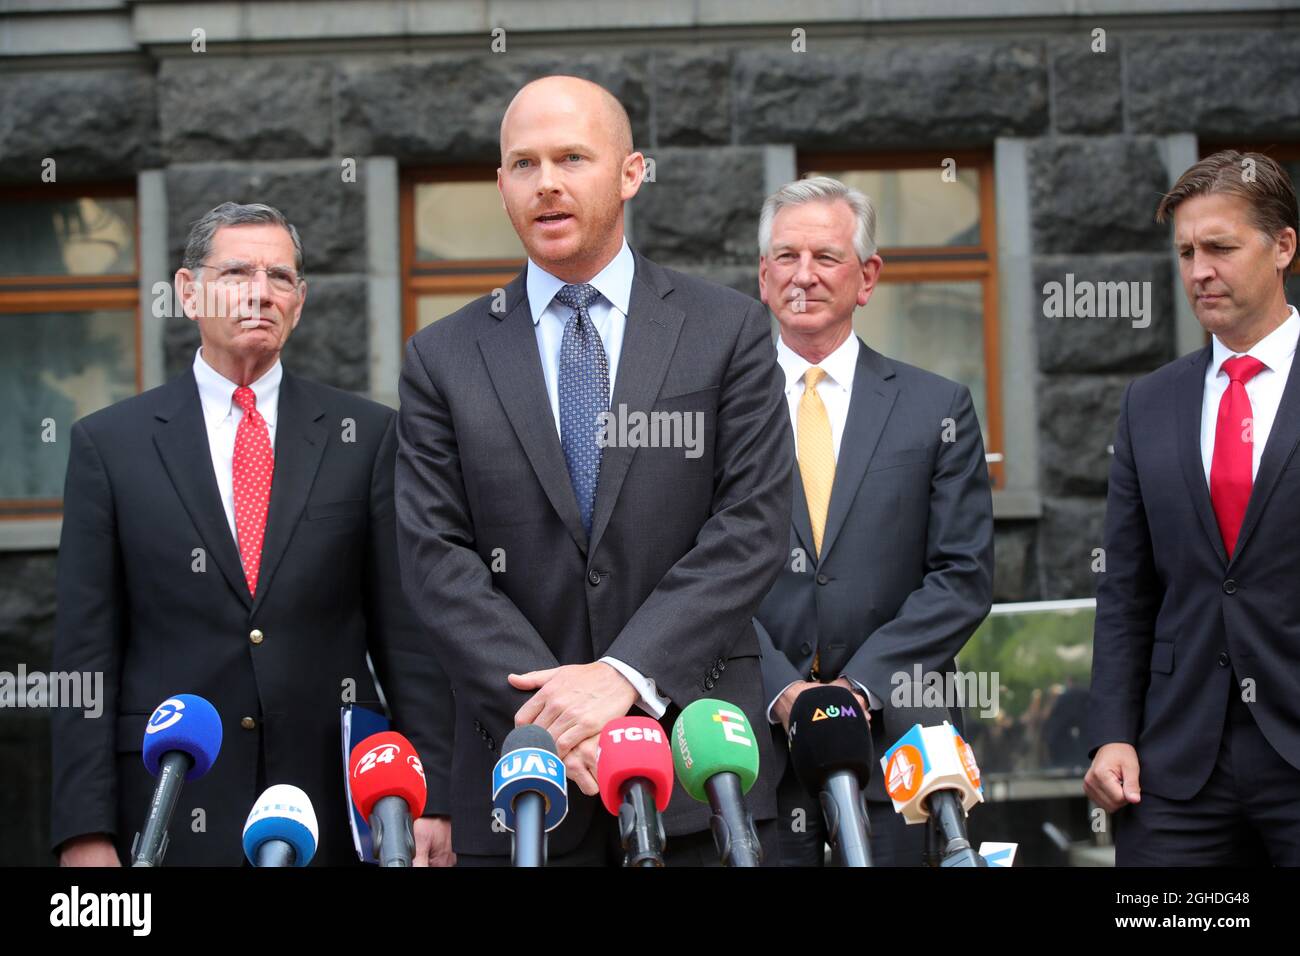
(789, 685), (874, 866)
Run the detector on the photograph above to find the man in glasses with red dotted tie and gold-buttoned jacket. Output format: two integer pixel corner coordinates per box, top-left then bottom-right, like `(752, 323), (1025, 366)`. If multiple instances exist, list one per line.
(51, 203), (452, 866)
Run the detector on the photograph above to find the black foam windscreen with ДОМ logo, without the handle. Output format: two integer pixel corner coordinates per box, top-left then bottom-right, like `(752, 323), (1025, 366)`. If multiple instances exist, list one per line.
(789, 685), (874, 796)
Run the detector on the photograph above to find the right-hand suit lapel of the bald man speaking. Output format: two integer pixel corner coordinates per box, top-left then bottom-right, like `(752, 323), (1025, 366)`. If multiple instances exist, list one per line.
(592, 254), (685, 550)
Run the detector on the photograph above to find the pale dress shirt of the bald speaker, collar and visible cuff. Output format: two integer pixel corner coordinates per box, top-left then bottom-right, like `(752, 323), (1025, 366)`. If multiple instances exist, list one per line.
(525, 239), (671, 718)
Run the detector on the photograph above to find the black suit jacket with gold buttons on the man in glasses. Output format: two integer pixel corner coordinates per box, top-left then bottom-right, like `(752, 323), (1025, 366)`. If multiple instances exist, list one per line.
(51, 371), (451, 865)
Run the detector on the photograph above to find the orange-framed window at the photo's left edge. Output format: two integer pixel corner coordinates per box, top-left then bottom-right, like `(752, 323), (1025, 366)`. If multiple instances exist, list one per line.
(0, 183), (140, 519)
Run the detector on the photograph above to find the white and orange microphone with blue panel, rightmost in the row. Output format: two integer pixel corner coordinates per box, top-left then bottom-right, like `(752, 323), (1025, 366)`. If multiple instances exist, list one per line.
(880, 687), (988, 866)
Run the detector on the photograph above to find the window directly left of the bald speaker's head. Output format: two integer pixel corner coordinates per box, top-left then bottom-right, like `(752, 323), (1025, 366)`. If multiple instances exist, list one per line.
(402, 168), (527, 337)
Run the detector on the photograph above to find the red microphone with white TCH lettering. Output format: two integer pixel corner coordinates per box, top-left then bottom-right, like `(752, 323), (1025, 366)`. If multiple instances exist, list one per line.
(595, 717), (672, 866)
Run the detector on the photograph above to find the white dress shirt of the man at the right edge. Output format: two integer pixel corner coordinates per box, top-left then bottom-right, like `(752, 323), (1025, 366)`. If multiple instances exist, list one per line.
(1201, 306), (1300, 484)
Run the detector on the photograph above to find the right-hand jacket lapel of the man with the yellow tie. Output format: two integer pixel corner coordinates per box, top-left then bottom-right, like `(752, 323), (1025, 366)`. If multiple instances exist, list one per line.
(821, 339), (898, 563)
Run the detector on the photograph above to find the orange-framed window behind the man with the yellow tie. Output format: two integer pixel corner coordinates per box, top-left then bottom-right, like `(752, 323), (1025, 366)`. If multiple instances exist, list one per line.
(800, 152), (1004, 489)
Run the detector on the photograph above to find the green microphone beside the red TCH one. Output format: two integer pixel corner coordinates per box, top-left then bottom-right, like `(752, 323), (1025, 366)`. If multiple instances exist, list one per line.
(672, 697), (763, 866)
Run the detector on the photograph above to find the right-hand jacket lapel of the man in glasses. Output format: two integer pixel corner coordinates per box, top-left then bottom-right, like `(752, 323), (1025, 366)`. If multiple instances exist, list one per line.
(244, 372), (327, 611)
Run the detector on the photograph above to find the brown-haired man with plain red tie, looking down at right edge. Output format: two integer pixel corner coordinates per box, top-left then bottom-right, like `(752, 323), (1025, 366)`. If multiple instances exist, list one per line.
(1084, 151), (1300, 866)
